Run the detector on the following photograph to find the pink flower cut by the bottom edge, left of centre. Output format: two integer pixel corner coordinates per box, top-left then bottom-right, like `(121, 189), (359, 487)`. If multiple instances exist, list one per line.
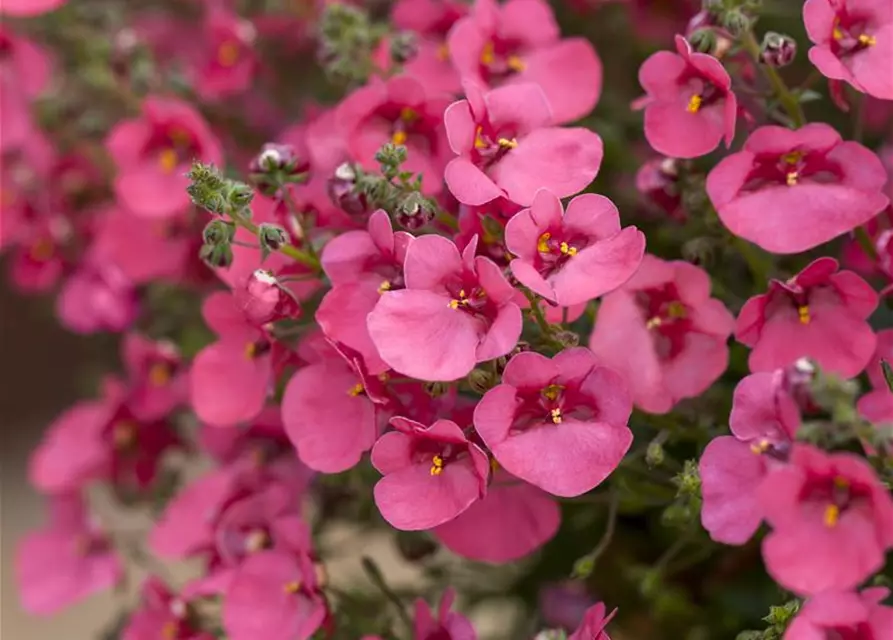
(223, 550), (327, 640)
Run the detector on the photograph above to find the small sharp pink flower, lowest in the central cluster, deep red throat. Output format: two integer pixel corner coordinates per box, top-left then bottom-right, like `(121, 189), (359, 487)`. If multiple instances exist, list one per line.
(372, 418), (490, 531)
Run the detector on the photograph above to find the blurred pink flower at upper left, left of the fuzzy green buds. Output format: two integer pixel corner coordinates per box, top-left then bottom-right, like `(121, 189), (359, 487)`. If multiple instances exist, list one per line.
(106, 96), (223, 218)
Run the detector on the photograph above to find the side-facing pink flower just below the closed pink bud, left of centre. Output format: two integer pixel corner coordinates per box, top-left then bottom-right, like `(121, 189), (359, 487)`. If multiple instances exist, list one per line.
(189, 291), (274, 427)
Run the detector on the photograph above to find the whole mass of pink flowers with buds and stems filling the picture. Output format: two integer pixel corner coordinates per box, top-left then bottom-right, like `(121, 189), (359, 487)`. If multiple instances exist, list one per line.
(0, 0), (893, 640)
